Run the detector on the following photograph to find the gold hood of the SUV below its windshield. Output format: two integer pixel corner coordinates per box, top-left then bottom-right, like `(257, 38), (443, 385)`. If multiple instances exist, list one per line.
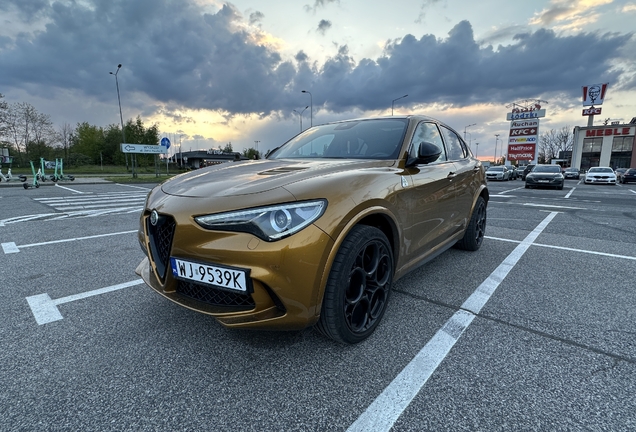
(161, 159), (395, 198)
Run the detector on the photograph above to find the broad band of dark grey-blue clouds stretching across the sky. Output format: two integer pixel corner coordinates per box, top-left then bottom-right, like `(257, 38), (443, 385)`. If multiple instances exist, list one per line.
(0, 0), (636, 121)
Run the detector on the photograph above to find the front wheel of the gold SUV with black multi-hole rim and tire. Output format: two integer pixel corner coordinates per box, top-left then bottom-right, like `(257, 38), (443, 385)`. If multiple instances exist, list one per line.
(316, 225), (395, 344)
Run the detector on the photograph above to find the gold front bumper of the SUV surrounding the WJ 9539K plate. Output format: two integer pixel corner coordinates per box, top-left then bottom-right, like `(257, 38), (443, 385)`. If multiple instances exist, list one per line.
(136, 210), (334, 330)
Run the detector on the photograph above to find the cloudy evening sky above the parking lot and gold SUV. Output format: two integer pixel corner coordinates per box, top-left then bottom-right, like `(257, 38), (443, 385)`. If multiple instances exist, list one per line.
(0, 0), (636, 159)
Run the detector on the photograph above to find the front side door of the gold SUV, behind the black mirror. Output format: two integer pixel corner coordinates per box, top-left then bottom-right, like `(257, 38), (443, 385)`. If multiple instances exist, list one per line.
(398, 122), (456, 266)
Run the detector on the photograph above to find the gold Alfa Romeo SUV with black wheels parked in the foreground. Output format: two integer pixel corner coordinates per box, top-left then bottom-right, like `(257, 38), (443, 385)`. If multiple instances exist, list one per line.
(136, 116), (489, 343)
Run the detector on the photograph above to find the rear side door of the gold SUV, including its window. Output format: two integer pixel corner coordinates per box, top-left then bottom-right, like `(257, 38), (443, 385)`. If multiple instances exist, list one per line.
(440, 125), (480, 233)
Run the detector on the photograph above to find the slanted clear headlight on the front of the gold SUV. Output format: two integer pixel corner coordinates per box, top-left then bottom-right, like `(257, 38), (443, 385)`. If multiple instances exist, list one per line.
(194, 200), (327, 242)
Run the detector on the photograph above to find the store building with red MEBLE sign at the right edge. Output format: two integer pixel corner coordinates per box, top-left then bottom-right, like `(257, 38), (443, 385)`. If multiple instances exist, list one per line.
(572, 117), (636, 171)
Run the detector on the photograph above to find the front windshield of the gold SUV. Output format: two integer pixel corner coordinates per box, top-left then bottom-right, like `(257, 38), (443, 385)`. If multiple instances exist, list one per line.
(267, 119), (408, 159)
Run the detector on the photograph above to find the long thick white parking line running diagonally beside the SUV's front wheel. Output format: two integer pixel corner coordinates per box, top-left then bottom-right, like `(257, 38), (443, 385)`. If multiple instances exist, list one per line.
(347, 213), (558, 432)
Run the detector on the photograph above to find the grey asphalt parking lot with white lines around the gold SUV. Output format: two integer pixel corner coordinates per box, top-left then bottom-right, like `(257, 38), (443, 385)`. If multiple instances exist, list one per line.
(0, 180), (636, 431)
